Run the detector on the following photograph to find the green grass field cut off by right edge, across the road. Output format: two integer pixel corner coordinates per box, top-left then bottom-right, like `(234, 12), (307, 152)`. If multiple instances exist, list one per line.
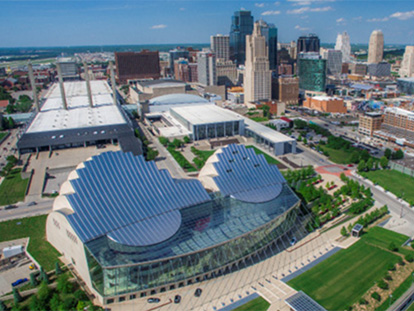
(361, 170), (414, 202)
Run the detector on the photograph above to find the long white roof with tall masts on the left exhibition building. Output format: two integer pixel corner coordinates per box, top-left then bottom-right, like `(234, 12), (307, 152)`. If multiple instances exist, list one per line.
(26, 81), (126, 133)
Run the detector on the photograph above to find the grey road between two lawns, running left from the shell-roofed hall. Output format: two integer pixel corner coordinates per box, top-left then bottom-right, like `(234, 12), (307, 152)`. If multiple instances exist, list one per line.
(0, 199), (54, 222)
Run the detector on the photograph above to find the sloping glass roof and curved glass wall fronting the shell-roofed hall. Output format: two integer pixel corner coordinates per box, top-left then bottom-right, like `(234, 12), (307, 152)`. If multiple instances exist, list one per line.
(85, 183), (300, 297)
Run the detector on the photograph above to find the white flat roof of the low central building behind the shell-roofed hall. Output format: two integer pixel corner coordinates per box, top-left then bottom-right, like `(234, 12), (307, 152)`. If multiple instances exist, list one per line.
(171, 105), (244, 125)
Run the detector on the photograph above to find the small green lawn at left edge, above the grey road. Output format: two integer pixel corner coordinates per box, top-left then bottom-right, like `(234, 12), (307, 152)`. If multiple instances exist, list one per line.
(0, 169), (29, 205)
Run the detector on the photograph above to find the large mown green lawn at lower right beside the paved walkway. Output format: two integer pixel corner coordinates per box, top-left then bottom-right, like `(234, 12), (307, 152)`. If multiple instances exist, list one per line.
(288, 228), (407, 310)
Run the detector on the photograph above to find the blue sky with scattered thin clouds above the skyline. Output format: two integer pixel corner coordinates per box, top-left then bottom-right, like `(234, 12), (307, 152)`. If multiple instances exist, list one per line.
(0, 0), (414, 47)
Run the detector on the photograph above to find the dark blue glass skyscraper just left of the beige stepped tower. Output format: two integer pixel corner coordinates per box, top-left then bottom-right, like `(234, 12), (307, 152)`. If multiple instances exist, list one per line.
(230, 11), (253, 65)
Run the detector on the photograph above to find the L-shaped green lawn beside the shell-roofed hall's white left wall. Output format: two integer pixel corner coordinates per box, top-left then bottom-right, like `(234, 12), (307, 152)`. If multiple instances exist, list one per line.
(0, 215), (60, 271)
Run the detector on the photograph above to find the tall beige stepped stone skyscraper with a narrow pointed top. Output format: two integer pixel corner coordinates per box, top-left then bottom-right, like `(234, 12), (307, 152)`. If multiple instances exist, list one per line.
(244, 22), (272, 102)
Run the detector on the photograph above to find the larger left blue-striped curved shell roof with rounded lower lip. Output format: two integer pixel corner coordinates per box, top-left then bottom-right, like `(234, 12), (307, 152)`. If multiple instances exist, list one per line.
(67, 152), (210, 246)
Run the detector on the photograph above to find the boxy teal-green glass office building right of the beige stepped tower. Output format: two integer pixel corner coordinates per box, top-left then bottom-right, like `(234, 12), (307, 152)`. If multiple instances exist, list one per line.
(298, 52), (326, 92)
